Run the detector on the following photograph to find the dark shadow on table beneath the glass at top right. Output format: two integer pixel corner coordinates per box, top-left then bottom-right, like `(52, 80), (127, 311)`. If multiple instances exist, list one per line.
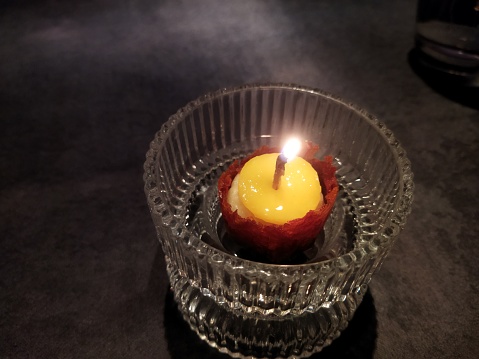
(408, 49), (479, 110)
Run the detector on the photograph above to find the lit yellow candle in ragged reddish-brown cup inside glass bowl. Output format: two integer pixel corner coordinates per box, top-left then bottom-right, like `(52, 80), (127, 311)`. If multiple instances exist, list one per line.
(218, 141), (339, 263)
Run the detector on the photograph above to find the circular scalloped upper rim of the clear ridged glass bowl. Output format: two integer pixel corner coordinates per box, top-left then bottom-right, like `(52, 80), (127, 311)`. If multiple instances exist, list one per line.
(143, 82), (414, 270)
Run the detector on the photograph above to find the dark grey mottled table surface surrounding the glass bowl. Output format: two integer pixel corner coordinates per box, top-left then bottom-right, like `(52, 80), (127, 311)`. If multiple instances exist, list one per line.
(0, 0), (479, 359)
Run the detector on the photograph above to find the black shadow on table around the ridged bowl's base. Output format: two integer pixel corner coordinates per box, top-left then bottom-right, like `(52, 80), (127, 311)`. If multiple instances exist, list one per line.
(164, 291), (377, 359)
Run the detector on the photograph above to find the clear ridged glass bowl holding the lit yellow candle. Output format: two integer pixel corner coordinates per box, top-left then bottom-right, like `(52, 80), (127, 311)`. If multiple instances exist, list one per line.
(144, 84), (414, 358)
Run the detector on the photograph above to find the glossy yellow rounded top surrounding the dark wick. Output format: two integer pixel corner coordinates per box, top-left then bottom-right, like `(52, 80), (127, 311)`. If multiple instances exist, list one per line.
(237, 153), (323, 224)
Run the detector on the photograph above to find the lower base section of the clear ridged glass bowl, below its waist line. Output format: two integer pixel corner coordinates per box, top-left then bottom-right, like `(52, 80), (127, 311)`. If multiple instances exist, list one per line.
(169, 268), (367, 359)
